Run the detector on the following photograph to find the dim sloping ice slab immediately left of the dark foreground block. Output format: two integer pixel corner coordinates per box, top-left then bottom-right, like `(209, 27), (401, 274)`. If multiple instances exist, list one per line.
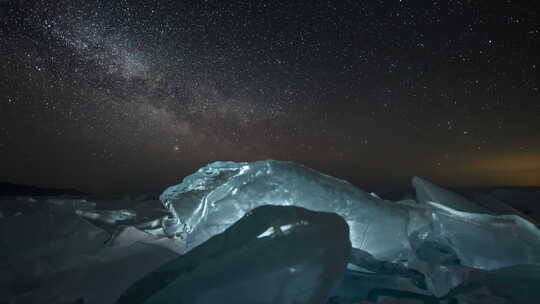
(10, 242), (177, 304)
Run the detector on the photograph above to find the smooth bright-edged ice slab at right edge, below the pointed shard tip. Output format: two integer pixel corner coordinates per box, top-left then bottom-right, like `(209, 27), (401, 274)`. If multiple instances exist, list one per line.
(422, 202), (540, 269)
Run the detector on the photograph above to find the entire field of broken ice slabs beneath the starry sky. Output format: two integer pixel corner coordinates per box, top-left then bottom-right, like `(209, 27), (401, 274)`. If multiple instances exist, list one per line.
(0, 161), (540, 304)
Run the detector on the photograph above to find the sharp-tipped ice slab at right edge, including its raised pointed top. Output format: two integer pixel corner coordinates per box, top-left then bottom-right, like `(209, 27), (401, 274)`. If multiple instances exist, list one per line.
(413, 177), (540, 270)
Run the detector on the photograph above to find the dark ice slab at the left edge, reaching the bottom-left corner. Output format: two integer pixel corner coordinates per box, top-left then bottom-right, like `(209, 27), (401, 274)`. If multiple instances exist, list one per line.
(0, 211), (110, 302)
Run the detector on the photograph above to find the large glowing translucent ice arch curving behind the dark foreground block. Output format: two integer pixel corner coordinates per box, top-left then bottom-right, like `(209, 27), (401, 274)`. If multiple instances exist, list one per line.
(160, 160), (410, 260)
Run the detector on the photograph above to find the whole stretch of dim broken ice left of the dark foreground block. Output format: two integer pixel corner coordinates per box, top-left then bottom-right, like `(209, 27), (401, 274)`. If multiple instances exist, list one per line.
(0, 197), (185, 304)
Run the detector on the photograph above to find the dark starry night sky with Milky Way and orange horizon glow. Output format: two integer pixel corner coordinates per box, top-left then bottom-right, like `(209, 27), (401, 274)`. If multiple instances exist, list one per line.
(0, 0), (540, 193)
